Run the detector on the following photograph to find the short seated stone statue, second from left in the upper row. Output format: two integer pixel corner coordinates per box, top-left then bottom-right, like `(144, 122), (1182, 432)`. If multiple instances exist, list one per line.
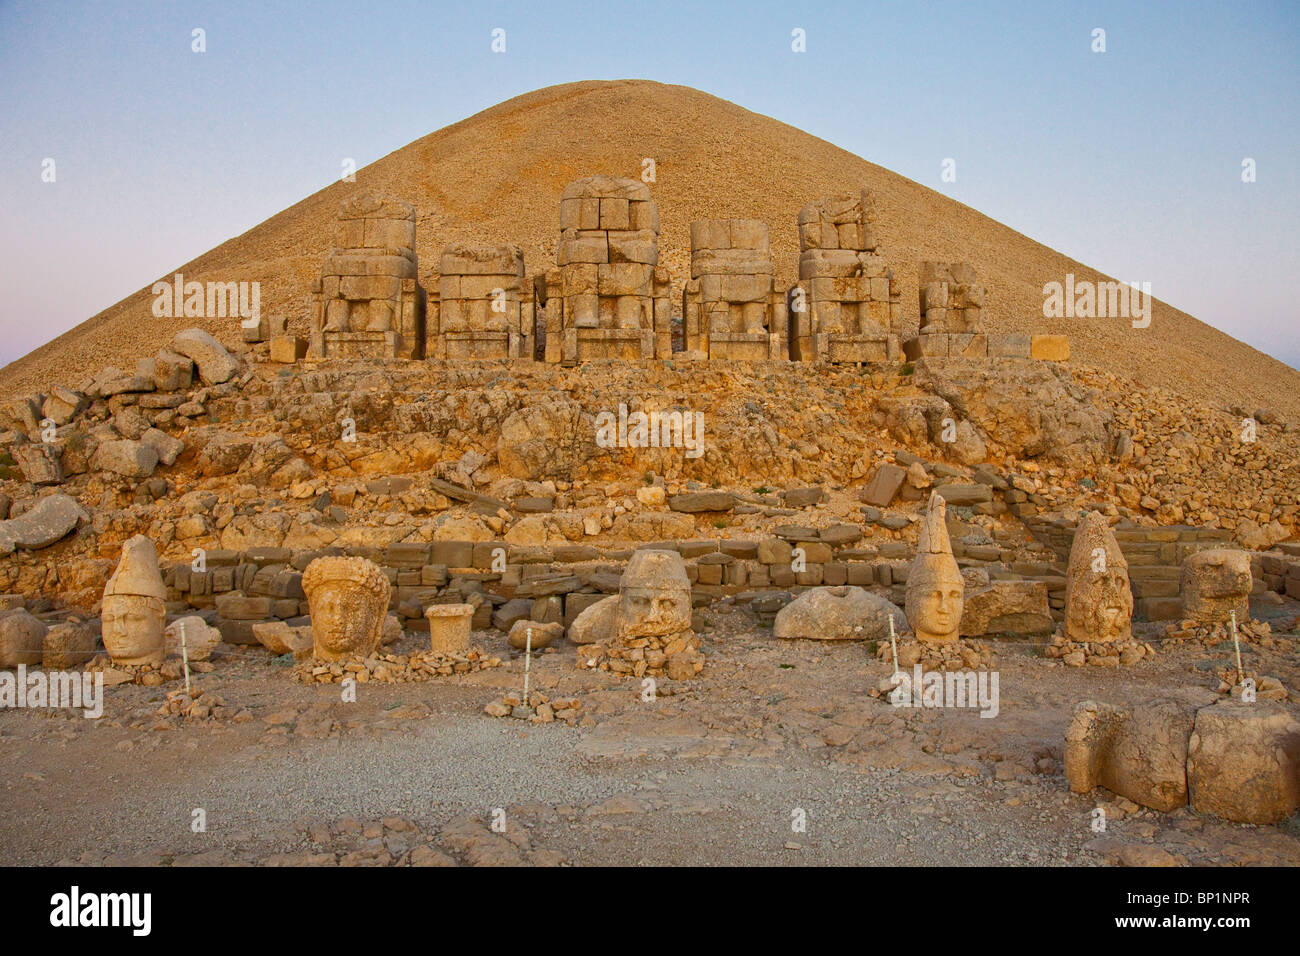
(425, 243), (534, 360)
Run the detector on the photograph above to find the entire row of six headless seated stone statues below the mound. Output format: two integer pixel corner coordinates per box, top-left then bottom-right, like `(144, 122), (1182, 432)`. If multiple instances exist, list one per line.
(299, 176), (998, 363)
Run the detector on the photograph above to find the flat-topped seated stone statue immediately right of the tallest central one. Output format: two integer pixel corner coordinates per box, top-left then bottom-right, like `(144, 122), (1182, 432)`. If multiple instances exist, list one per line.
(681, 219), (788, 362)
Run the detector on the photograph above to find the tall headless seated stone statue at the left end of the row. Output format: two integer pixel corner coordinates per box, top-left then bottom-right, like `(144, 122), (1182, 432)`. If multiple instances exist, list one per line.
(308, 193), (426, 359)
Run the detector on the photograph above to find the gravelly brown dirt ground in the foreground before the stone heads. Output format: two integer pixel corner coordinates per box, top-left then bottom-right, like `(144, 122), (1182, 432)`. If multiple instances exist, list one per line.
(0, 601), (1300, 866)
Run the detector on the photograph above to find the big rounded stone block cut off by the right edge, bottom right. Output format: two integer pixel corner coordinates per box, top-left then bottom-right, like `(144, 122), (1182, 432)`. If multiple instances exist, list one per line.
(1187, 700), (1300, 823)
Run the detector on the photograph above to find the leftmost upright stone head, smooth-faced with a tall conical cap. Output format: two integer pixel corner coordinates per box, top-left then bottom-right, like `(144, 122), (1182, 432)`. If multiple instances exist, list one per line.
(101, 535), (166, 663)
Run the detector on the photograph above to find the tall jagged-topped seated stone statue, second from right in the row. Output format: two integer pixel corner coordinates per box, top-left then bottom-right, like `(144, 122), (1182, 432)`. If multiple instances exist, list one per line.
(789, 190), (902, 363)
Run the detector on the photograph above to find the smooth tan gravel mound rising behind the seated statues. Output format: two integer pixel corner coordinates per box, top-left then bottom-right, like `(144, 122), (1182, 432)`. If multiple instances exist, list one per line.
(0, 79), (1300, 420)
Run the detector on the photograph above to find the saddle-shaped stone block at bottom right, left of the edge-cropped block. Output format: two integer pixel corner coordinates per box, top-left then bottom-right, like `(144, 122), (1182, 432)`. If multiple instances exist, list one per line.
(1065, 698), (1193, 810)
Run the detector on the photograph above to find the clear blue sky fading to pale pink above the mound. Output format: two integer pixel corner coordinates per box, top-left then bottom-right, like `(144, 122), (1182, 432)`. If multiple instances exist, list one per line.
(0, 0), (1300, 367)
